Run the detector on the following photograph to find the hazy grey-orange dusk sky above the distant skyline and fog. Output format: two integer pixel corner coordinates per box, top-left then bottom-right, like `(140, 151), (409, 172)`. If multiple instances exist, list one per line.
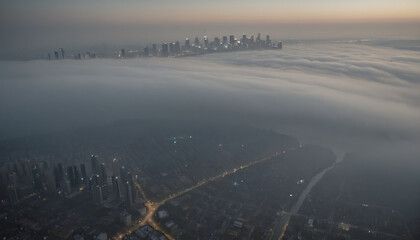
(0, 0), (420, 59)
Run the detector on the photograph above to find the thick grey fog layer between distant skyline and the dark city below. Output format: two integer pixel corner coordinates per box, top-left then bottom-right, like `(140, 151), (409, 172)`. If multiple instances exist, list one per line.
(0, 43), (420, 154)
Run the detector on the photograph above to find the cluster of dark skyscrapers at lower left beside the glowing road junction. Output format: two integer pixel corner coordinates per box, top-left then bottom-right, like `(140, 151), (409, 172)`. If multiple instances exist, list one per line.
(0, 155), (140, 207)
